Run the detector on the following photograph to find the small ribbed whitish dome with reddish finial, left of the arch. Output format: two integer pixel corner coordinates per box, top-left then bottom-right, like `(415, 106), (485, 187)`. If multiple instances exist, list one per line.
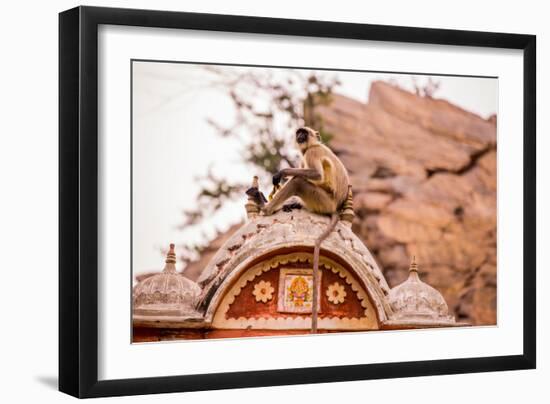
(133, 244), (201, 316)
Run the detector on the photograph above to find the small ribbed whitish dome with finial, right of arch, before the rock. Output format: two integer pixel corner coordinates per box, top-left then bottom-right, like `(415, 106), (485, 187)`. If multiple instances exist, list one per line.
(388, 256), (455, 323)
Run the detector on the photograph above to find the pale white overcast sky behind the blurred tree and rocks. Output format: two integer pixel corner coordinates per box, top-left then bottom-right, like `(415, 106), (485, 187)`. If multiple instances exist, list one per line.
(132, 62), (498, 273)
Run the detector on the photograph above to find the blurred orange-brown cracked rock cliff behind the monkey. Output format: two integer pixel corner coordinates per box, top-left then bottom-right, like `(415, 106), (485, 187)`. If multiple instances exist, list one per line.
(316, 82), (497, 324)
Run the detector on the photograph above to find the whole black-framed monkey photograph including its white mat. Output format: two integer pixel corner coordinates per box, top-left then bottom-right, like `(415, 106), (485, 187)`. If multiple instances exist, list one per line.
(59, 7), (536, 397)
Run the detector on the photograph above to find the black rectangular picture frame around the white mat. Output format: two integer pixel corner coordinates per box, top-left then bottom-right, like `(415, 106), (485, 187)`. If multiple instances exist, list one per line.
(59, 7), (536, 397)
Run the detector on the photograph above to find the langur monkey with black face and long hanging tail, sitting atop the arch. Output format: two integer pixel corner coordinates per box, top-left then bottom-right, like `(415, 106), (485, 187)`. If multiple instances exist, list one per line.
(246, 127), (349, 333)
